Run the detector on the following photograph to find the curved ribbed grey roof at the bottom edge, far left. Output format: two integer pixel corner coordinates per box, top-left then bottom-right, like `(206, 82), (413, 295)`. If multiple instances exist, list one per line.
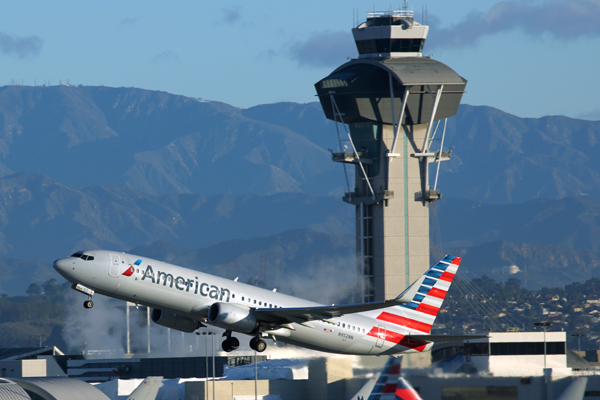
(12, 377), (110, 400)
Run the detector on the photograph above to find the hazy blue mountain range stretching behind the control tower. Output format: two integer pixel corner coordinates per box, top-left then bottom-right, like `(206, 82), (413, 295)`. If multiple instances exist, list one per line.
(0, 85), (600, 300)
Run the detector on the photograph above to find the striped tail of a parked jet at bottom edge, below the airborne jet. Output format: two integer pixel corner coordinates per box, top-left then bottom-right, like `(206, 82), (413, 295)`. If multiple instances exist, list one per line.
(350, 356), (423, 400)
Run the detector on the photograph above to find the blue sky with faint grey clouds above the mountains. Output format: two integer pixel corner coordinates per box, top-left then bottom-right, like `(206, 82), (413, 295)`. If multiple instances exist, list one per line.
(0, 0), (600, 119)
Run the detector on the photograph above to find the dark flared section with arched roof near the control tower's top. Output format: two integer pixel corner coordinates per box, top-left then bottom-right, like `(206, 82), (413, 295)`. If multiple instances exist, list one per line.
(315, 57), (467, 125)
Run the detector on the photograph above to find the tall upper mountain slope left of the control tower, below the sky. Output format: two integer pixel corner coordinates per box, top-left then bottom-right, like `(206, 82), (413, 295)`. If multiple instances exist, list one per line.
(0, 86), (343, 195)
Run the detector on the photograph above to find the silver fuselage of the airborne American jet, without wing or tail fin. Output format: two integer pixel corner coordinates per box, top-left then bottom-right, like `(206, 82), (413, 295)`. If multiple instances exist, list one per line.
(54, 250), (431, 355)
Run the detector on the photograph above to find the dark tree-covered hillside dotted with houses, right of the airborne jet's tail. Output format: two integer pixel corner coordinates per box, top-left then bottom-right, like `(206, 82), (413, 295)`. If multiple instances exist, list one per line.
(434, 276), (600, 349)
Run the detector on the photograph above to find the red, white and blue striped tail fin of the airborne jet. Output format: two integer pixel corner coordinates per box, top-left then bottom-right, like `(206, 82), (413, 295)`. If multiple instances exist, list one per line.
(377, 255), (461, 333)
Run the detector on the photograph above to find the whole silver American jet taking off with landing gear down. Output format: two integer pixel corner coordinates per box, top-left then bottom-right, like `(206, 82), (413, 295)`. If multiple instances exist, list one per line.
(53, 250), (480, 355)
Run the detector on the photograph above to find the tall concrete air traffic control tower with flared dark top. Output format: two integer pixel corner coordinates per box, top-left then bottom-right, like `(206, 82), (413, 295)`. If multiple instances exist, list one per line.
(315, 10), (467, 302)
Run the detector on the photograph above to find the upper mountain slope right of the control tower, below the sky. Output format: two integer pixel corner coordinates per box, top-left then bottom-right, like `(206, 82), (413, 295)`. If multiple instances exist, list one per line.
(440, 105), (600, 204)
